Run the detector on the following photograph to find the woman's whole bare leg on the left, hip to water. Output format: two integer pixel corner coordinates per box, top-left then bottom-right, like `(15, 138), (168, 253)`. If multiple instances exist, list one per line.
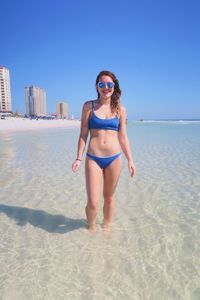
(85, 157), (102, 230)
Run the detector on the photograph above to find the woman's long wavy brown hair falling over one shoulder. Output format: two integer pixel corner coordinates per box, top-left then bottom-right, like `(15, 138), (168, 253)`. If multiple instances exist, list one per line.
(96, 71), (122, 114)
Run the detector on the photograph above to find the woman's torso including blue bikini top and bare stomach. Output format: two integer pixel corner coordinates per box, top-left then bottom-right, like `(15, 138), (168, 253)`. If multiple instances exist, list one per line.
(87, 101), (120, 157)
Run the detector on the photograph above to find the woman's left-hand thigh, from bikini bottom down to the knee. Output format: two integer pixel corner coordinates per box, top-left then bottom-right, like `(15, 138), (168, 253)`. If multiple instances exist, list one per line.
(85, 157), (102, 204)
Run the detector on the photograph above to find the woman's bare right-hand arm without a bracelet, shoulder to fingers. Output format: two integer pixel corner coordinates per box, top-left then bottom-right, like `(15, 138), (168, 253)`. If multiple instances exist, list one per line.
(118, 106), (136, 177)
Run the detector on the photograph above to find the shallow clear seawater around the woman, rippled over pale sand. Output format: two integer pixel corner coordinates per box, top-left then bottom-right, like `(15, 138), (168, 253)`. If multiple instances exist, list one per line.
(0, 122), (200, 300)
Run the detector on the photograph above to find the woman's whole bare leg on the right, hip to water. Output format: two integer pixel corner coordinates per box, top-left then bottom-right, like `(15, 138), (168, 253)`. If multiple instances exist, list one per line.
(103, 156), (122, 227)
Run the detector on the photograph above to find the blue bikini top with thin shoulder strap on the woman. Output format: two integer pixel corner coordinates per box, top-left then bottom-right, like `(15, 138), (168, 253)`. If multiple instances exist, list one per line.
(88, 101), (119, 131)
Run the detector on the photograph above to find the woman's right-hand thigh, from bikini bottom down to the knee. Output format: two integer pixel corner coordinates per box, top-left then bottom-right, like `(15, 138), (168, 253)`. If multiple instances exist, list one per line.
(103, 155), (122, 197)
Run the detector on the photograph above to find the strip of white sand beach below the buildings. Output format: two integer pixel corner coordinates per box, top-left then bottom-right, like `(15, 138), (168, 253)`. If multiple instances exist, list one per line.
(0, 118), (80, 132)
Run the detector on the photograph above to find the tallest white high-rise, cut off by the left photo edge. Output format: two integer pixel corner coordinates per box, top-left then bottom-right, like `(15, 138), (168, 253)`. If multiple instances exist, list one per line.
(0, 66), (12, 113)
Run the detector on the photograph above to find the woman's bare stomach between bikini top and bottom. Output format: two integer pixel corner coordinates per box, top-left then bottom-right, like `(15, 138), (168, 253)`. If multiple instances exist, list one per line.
(87, 129), (120, 157)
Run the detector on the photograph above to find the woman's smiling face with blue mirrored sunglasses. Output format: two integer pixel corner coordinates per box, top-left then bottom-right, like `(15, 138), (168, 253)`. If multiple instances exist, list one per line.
(96, 75), (114, 99)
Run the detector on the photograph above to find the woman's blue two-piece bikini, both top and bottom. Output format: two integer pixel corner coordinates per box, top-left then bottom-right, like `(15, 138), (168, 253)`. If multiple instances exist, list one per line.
(86, 101), (121, 169)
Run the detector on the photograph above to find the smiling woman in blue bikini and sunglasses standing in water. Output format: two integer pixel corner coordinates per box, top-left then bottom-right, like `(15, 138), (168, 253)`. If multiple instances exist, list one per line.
(72, 71), (135, 231)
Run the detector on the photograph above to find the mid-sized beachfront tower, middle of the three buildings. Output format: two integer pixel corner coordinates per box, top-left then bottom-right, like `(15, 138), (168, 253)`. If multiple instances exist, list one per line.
(25, 85), (46, 117)
